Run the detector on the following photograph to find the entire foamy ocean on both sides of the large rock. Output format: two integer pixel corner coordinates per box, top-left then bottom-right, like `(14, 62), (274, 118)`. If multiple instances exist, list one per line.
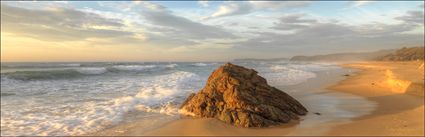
(1, 61), (340, 136)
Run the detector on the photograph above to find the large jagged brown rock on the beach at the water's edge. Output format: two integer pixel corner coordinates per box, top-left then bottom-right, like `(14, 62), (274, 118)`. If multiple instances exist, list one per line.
(180, 63), (307, 127)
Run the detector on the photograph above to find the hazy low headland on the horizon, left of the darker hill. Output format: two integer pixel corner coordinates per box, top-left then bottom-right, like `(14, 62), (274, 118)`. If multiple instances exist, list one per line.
(290, 50), (395, 62)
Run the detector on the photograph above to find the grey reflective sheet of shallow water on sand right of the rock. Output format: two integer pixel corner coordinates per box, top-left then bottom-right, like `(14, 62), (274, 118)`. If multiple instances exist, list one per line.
(290, 92), (377, 135)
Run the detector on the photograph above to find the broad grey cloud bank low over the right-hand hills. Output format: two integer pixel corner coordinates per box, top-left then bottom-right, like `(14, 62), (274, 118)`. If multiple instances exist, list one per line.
(236, 13), (424, 56)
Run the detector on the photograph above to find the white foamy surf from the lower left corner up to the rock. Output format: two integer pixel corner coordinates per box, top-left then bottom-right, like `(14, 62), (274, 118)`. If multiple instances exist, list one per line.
(1, 71), (200, 136)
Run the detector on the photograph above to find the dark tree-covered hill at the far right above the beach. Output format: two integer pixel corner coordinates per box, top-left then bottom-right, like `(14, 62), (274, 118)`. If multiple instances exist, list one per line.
(376, 47), (424, 61)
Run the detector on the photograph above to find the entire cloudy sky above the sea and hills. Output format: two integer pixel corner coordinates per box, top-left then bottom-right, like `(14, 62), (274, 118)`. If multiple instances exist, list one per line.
(1, 1), (424, 62)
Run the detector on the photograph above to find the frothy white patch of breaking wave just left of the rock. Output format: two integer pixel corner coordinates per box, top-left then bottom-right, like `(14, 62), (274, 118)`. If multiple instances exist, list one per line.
(135, 72), (202, 115)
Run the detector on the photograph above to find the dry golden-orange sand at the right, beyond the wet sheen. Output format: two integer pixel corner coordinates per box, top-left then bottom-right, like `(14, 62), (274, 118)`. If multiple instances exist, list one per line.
(327, 61), (424, 136)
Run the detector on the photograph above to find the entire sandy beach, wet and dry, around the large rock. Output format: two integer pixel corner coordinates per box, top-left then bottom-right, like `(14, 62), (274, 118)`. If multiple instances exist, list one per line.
(90, 62), (424, 136)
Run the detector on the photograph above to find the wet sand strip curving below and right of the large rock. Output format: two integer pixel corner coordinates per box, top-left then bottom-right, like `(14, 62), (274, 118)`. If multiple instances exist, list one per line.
(89, 63), (373, 136)
